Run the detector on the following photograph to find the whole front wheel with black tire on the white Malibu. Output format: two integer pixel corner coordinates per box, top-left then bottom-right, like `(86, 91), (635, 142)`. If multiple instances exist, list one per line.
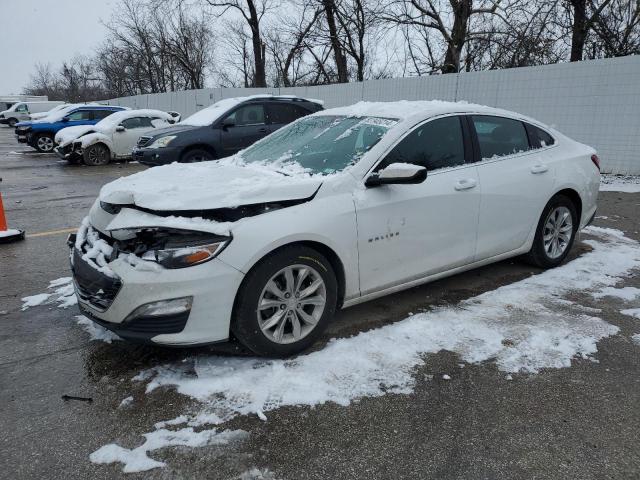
(231, 245), (338, 357)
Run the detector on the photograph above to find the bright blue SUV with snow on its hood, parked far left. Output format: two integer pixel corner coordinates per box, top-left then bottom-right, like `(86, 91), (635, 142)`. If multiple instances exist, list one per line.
(15, 105), (126, 153)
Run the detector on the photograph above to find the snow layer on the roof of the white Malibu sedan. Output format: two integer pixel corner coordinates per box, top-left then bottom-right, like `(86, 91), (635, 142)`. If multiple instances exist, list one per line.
(314, 100), (524, 121)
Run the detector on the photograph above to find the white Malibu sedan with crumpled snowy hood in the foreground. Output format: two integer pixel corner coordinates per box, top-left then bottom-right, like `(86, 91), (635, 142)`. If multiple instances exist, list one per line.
(69, 101), (600, 356)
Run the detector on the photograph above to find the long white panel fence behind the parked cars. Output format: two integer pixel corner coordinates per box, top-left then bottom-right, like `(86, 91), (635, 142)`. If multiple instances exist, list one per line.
(109, 56), (640, 174)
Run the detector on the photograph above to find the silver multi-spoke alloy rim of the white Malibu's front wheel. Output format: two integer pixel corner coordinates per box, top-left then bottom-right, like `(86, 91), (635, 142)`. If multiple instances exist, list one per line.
(256, 265), (327, 344)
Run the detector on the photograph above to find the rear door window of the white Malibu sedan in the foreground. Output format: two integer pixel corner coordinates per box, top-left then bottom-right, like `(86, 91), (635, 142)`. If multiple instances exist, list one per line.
(471, 115), (529, 160)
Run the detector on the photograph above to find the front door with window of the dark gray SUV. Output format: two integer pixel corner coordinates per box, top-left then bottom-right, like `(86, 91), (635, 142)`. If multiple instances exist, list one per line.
(220, 103), (269, 157)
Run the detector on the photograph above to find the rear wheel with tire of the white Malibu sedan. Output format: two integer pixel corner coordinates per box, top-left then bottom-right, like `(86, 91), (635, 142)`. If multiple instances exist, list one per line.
(525, 194), (580, 268)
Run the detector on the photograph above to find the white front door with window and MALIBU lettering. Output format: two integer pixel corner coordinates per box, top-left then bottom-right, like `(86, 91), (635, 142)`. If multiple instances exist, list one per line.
(355, 116), (480, 295)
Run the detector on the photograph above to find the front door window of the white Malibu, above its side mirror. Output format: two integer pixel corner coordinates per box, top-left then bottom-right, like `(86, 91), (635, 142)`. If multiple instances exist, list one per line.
(376, 117), (465, 170)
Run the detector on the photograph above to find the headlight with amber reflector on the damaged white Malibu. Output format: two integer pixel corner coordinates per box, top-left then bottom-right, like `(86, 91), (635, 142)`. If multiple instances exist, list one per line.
(142, 232), (231, 268)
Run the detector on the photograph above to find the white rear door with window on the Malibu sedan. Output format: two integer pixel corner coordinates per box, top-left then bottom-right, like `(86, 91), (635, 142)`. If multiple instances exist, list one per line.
(469, 115), (554, 260)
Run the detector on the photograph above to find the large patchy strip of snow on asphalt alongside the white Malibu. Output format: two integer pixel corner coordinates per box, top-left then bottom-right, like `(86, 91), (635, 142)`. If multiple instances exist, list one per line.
(91, 227), (640, 471)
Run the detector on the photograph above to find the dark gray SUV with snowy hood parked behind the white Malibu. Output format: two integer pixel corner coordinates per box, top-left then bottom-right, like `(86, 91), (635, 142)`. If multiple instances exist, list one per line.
(133, 95), (322, 166)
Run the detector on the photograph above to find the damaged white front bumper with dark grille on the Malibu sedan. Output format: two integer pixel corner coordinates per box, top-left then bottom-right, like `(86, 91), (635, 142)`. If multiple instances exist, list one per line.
(68, 221), (243, 346)
